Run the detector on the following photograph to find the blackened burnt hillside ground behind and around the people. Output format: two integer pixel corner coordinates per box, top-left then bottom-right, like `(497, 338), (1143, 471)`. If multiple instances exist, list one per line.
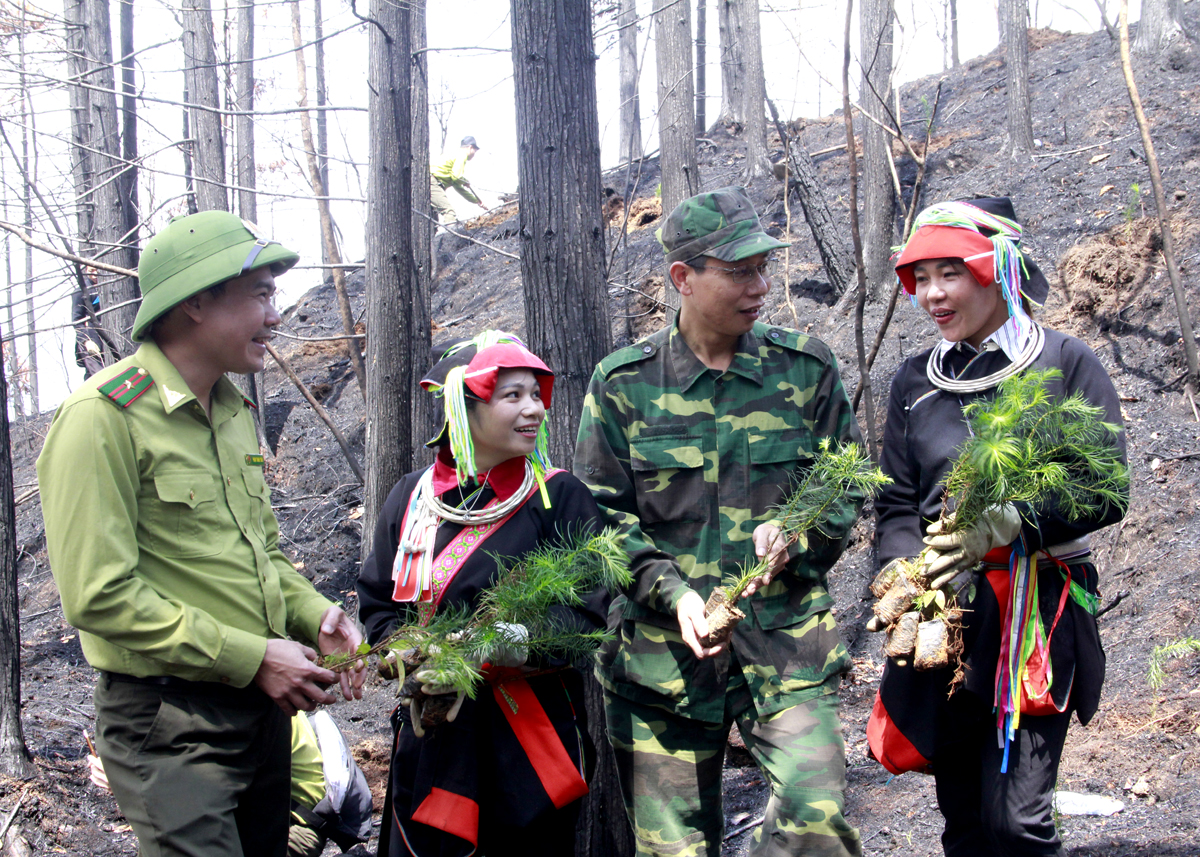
(7, 11), (1200, 857)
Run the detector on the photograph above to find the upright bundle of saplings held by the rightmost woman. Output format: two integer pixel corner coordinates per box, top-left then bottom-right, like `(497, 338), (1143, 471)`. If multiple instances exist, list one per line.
(869, 368), (1129, 670)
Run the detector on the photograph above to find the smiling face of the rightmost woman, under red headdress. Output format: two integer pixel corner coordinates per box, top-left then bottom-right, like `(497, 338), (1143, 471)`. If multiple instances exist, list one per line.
(912, 258), (1008, 348)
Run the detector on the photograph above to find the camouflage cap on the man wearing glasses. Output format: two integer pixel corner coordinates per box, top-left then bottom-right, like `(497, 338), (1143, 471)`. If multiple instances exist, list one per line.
(655, 187), (791, 263)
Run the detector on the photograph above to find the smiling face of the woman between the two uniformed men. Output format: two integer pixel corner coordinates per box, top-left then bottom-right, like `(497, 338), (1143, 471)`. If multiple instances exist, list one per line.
(467, 368), (546, 473)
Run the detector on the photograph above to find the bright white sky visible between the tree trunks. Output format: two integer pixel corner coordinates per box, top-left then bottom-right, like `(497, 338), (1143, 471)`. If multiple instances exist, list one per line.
(0, 0), (1140, 409)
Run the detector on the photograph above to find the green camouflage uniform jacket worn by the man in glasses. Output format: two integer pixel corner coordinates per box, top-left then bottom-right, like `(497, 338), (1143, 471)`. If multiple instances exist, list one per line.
(575, 324), (862, 723)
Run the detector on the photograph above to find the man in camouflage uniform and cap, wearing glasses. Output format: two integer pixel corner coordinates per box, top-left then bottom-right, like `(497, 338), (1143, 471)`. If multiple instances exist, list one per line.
(575, 187), (862, 857)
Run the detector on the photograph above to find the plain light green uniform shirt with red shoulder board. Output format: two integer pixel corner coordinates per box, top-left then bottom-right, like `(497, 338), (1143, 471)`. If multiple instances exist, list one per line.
(37, 342), (330, 688)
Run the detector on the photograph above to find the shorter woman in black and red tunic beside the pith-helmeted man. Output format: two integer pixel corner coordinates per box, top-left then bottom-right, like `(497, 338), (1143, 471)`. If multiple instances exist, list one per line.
(358, 331), (607, 857)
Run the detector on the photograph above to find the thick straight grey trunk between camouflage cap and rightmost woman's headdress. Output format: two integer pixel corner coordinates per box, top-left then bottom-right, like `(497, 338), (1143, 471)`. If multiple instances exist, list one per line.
(858, 0), (895, 299)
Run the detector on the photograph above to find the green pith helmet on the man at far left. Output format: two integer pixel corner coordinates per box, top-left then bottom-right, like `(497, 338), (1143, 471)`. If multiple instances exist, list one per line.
(133, 211), (300, 342)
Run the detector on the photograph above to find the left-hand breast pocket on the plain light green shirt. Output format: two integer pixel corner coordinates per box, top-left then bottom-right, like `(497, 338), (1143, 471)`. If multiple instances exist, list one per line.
(144, 471), (221, 558)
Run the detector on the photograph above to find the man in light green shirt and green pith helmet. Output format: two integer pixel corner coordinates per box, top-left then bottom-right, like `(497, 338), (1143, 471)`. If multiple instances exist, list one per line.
(37, 211), (362, 857)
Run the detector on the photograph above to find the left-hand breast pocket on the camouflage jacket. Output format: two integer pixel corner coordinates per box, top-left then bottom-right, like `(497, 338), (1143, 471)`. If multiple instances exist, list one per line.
(629, 435), (708, 525)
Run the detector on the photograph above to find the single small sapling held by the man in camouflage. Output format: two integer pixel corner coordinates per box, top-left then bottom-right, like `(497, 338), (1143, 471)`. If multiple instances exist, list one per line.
(704, 438), (892, 646)
